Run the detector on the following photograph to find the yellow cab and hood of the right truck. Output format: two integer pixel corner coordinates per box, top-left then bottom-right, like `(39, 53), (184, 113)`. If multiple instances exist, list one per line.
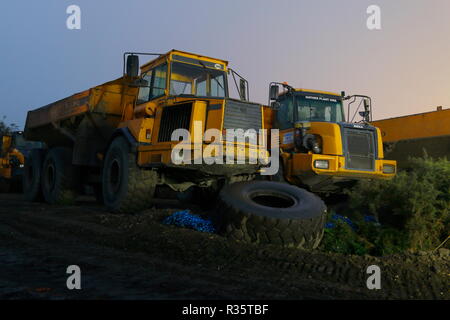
(265, 82), (396, 193)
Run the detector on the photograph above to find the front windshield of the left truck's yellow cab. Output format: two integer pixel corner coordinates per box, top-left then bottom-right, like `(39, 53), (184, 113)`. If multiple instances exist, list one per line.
(170, 62), (226, 98)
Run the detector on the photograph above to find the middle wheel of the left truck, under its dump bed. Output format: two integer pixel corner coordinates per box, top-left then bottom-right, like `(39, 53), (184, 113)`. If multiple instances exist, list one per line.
(41, 147), (76, 204)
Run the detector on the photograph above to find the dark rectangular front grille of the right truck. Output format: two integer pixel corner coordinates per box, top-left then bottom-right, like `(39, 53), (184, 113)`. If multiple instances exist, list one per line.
(342, 128), (375, 171)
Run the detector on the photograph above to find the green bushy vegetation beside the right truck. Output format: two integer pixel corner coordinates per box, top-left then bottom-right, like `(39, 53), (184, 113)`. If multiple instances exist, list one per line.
(321, 157), (450, 255)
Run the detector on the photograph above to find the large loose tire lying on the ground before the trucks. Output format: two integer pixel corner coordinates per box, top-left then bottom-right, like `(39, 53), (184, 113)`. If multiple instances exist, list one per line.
(213, 181), (326, 249)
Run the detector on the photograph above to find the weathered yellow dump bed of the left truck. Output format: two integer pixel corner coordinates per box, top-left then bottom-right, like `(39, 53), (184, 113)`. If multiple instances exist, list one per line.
(24, 78), (138, 165)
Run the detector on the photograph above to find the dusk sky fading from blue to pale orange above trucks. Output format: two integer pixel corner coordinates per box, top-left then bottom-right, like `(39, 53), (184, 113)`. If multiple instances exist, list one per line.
(0, 0), (450, 127)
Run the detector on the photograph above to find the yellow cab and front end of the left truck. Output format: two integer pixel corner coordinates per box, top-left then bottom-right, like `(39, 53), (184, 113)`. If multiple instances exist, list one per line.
(122, 50), (267, 172)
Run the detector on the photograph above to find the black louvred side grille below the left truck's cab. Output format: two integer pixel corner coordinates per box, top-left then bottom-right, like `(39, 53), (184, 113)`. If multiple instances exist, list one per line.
(158, 103), (192, 142)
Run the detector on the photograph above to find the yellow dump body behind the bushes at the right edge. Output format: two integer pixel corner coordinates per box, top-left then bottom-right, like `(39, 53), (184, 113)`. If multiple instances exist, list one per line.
(372, 107), (450, 168)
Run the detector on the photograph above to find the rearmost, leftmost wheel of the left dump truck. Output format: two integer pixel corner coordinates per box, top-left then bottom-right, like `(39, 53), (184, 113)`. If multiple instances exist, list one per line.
(22, 149), (45, 201)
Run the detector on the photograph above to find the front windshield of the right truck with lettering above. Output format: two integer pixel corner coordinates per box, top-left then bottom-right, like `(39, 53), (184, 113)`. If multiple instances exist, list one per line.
(295, 95), (344, 122)
